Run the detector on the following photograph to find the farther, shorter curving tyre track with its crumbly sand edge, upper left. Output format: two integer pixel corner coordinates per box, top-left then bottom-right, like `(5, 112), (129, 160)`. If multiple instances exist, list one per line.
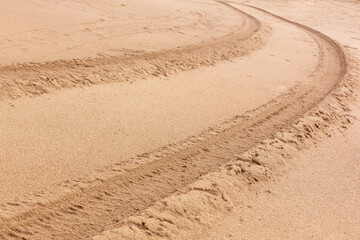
(0, 1), (269, 100)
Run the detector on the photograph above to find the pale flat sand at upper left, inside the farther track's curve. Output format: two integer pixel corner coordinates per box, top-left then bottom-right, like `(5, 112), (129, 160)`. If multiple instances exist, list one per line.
(0, 0), (242, 65)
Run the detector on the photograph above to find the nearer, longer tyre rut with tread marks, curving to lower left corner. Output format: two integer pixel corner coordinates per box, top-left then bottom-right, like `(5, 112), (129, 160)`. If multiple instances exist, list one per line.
(0, 3), (347, 239)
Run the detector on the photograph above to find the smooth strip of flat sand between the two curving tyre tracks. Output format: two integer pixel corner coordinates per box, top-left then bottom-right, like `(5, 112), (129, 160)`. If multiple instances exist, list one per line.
(0, 10), (318, 203)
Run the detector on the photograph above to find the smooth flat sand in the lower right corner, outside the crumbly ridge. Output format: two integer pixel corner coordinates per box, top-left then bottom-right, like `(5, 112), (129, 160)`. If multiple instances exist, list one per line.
(203, 106), (360, 239)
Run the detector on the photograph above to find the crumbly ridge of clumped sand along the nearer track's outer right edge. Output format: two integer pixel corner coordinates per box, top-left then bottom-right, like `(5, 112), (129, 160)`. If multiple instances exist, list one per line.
(89, 4), (360, 240)
